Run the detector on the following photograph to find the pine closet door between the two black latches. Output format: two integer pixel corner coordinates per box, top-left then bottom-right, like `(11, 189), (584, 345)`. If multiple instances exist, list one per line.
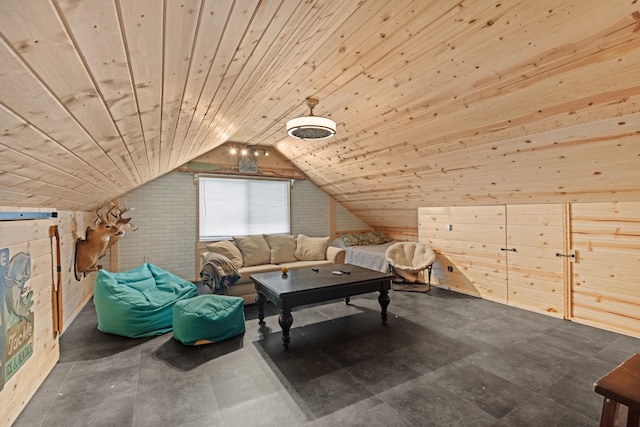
(503, 204), (567, 317)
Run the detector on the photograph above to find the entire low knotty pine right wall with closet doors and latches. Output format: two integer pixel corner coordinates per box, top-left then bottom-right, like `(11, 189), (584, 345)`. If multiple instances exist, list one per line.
(419, 202), (640, 337)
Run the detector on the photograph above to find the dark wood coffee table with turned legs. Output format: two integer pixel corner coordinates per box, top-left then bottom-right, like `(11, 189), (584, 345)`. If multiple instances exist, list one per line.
(250, 264), (393, 347)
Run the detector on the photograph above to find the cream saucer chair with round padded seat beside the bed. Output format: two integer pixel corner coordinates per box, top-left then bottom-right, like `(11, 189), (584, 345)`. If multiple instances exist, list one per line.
(384, 242), (436, 292)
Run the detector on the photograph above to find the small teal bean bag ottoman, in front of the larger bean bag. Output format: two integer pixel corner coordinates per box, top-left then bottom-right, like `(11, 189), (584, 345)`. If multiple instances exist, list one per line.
(173, 295), (245, 345)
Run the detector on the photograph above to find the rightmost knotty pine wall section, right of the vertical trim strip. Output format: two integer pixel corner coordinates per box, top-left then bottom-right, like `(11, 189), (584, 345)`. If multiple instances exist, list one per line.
(570, 202), (640, 338)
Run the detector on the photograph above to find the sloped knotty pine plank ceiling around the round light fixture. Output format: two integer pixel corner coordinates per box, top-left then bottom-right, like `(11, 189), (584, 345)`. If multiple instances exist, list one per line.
(0, 0), (640, 234)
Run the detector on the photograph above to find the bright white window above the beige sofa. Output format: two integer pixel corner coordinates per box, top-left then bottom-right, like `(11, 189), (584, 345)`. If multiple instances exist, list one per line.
(198, 177), (290, 240)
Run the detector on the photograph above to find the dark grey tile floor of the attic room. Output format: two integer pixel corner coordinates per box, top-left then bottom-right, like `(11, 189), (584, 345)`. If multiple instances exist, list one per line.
(14, 289), (640, 427)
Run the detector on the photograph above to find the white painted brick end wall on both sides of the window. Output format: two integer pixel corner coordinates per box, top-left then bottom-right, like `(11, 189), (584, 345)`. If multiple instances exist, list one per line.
(119, 172), (368, 280)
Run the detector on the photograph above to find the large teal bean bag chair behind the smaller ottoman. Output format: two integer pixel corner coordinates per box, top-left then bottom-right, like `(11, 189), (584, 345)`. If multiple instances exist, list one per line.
(93, 263), (198, 338)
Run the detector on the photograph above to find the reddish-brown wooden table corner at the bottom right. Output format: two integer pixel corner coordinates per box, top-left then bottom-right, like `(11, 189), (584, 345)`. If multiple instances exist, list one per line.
(593, 353), (640, 427)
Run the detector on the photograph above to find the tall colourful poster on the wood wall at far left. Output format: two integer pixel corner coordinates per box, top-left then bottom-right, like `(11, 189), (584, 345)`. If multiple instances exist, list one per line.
(0, 248), (34, 390)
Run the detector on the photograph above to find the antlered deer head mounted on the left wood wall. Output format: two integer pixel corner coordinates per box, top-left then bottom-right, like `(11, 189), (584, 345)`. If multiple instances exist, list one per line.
(75, 200), (138, 280)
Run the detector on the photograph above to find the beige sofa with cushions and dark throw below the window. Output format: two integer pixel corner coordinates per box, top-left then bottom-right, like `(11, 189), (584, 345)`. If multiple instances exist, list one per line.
(201, 234), (346, 304)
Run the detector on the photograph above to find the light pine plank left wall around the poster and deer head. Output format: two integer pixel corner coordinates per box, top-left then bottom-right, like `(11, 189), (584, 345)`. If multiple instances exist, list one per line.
(0, 207), (95, 426)
